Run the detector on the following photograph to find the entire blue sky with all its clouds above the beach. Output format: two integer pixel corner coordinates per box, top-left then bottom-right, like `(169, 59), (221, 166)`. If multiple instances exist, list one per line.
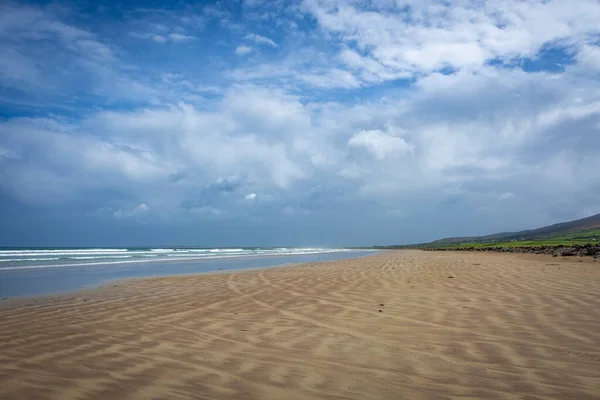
(0, 0), (600, 246)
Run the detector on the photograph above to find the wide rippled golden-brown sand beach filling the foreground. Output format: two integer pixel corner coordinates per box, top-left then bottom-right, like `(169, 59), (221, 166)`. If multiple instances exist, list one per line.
(0, 251), (600, 400)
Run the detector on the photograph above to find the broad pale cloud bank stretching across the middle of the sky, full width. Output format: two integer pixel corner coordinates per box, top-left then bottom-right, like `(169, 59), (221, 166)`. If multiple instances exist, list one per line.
(0, 63), (600, 219)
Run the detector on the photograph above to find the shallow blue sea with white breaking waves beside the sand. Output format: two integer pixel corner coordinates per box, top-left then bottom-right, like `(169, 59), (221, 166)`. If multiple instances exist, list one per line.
(0, 247), (371, 298)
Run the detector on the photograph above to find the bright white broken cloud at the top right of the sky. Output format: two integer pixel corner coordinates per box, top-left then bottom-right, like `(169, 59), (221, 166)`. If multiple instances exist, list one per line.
(303, 0), (600, 81)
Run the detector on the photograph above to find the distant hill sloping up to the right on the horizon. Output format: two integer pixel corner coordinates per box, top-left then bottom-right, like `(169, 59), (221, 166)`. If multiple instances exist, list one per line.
(382, 214), (600, 247)
